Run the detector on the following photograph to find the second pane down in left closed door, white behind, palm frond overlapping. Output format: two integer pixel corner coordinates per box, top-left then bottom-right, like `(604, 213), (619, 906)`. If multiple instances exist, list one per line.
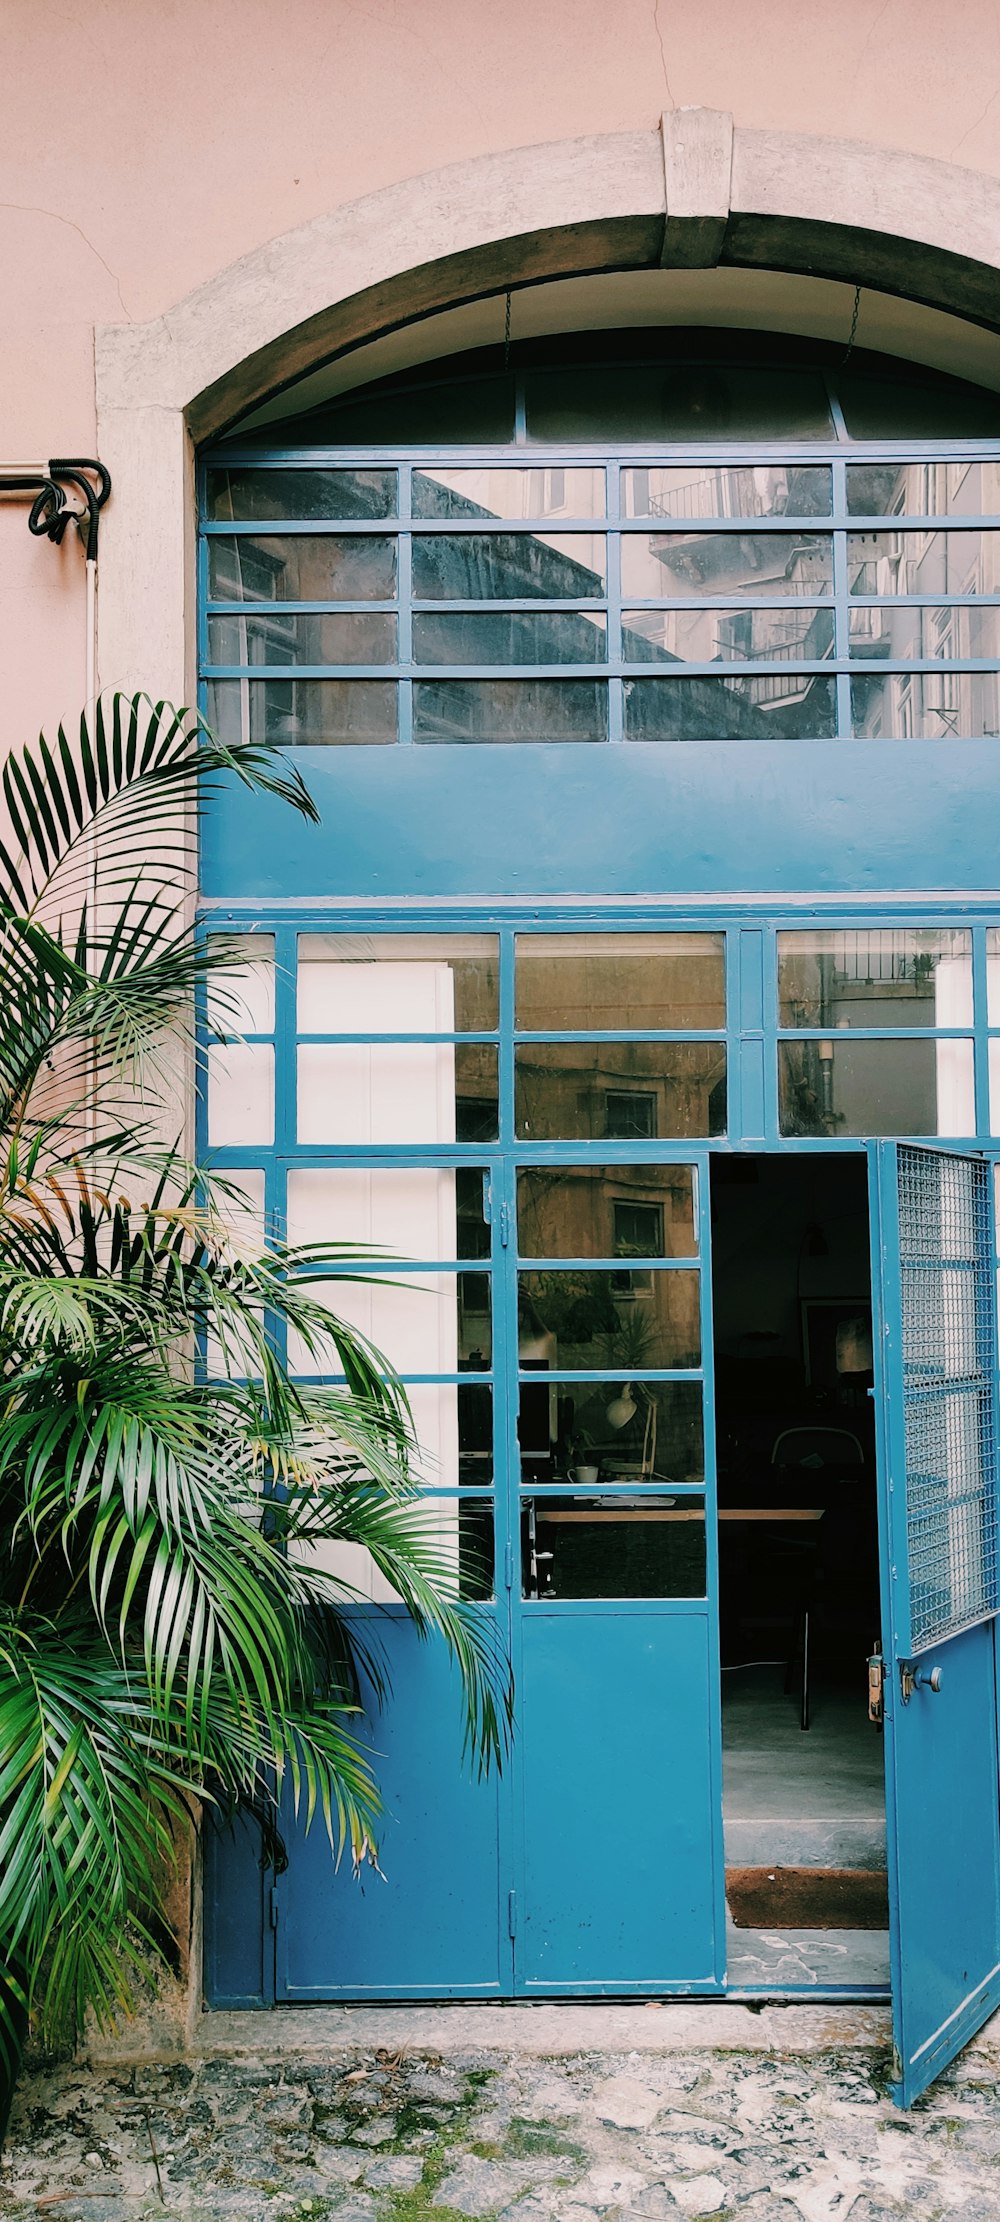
(289, 1260), (493, 1375)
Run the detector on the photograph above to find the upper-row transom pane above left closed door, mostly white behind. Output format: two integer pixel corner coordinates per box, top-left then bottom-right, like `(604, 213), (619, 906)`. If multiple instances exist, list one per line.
(298, 933), (500, 1033)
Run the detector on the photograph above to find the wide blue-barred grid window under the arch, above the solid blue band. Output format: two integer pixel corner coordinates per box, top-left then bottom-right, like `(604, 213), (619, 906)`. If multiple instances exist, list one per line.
(202, 442), (1000, 747)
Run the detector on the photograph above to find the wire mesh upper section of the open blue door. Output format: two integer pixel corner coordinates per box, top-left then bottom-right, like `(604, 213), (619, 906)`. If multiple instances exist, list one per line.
(898, 1144), (1000, 1653)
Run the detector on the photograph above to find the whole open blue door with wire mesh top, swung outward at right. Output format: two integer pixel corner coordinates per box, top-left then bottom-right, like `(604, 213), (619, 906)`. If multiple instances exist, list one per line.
(871, 1142), (1000, 2106)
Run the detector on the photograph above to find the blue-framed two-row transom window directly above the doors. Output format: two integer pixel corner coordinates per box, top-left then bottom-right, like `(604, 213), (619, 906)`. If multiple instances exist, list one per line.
(202, 904), (1000, 1182)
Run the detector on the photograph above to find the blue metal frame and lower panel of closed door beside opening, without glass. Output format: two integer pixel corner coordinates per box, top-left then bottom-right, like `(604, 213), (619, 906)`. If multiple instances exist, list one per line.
(507, 1144), (724, 1998)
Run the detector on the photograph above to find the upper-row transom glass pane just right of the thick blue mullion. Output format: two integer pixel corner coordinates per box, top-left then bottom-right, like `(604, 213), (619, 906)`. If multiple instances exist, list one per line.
(778, 927), (971, 1031)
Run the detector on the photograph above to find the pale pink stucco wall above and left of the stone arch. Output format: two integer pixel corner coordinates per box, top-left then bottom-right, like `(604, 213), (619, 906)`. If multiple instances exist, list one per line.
(0, 0), (1000, 738)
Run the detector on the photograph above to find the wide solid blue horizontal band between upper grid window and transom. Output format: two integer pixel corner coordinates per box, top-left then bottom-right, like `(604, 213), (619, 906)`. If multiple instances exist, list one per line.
(202, 740), (1000, 900)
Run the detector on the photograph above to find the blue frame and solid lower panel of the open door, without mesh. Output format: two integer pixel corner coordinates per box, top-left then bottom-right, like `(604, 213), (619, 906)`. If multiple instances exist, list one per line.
(873, 1144), (1000, 2106)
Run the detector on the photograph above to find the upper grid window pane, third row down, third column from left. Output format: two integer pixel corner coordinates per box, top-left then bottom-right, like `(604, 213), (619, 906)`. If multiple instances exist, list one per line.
(622, 604), (835, 664)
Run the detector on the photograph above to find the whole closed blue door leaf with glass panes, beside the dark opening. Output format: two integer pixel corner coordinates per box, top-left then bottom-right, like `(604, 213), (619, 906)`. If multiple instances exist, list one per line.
(509, 1144), (724, 1995)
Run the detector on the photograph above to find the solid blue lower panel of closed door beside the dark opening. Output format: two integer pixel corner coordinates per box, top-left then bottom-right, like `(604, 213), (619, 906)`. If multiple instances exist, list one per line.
(518, 1607), (722, 1993)
